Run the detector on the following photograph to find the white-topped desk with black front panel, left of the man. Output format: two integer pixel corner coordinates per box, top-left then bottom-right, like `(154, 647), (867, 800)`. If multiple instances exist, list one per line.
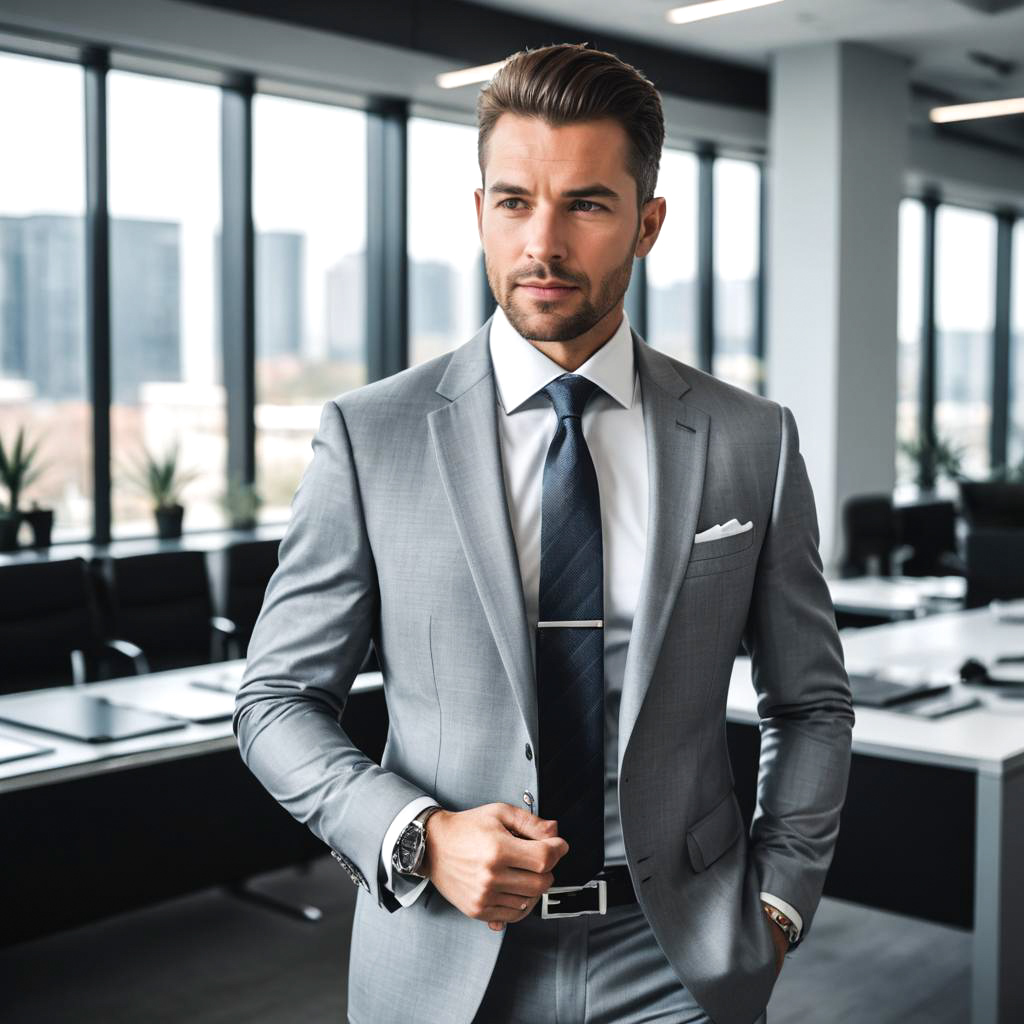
(0, 660), (387, 946)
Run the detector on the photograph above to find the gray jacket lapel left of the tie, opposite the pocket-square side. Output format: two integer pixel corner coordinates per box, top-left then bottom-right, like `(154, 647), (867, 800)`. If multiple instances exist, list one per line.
(427, 318), (538, 749)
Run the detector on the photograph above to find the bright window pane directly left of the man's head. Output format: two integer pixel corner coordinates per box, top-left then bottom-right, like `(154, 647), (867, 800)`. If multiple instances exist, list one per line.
(408, 118), (483, 366)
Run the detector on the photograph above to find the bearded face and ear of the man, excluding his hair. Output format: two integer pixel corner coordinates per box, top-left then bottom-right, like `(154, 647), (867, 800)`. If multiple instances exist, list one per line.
(476, 114), (665, 342)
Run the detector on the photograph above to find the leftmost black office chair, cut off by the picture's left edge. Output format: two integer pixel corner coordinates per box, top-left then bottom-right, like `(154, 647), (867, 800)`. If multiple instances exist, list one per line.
(0, 558), (142, 693)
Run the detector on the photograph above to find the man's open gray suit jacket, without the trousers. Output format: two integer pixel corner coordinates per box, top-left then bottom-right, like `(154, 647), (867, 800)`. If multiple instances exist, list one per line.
(233, 322), (853, 1024)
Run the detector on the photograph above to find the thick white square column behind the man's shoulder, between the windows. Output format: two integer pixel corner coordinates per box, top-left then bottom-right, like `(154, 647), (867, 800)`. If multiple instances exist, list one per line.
(766, 43), (908, 568)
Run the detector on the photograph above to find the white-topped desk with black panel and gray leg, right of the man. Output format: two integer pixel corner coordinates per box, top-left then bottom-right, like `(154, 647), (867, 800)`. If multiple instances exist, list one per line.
(728, 608), (1024, 1024)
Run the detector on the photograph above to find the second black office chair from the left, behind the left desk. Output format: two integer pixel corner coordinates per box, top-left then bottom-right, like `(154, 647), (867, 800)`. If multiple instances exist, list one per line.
(102, 551), (238, 672)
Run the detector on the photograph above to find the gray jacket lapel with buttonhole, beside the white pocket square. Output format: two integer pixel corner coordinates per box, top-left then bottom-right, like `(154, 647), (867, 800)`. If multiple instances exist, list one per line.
(618, 332), (709, 771)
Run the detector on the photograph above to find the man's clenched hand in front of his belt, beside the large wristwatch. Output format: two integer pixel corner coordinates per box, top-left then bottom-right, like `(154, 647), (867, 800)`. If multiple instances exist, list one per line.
(421, 803), (569, 932)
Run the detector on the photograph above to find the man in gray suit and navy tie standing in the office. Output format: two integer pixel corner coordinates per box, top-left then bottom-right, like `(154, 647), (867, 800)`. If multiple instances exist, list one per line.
(233, 39), (853, 1024)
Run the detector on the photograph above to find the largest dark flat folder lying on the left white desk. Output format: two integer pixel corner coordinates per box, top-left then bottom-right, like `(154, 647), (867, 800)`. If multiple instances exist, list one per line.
(0, 689), (185, 743)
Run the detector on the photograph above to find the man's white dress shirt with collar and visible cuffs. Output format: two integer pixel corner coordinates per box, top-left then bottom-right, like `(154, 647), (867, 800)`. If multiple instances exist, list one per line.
(381, 306), (802, 929)
